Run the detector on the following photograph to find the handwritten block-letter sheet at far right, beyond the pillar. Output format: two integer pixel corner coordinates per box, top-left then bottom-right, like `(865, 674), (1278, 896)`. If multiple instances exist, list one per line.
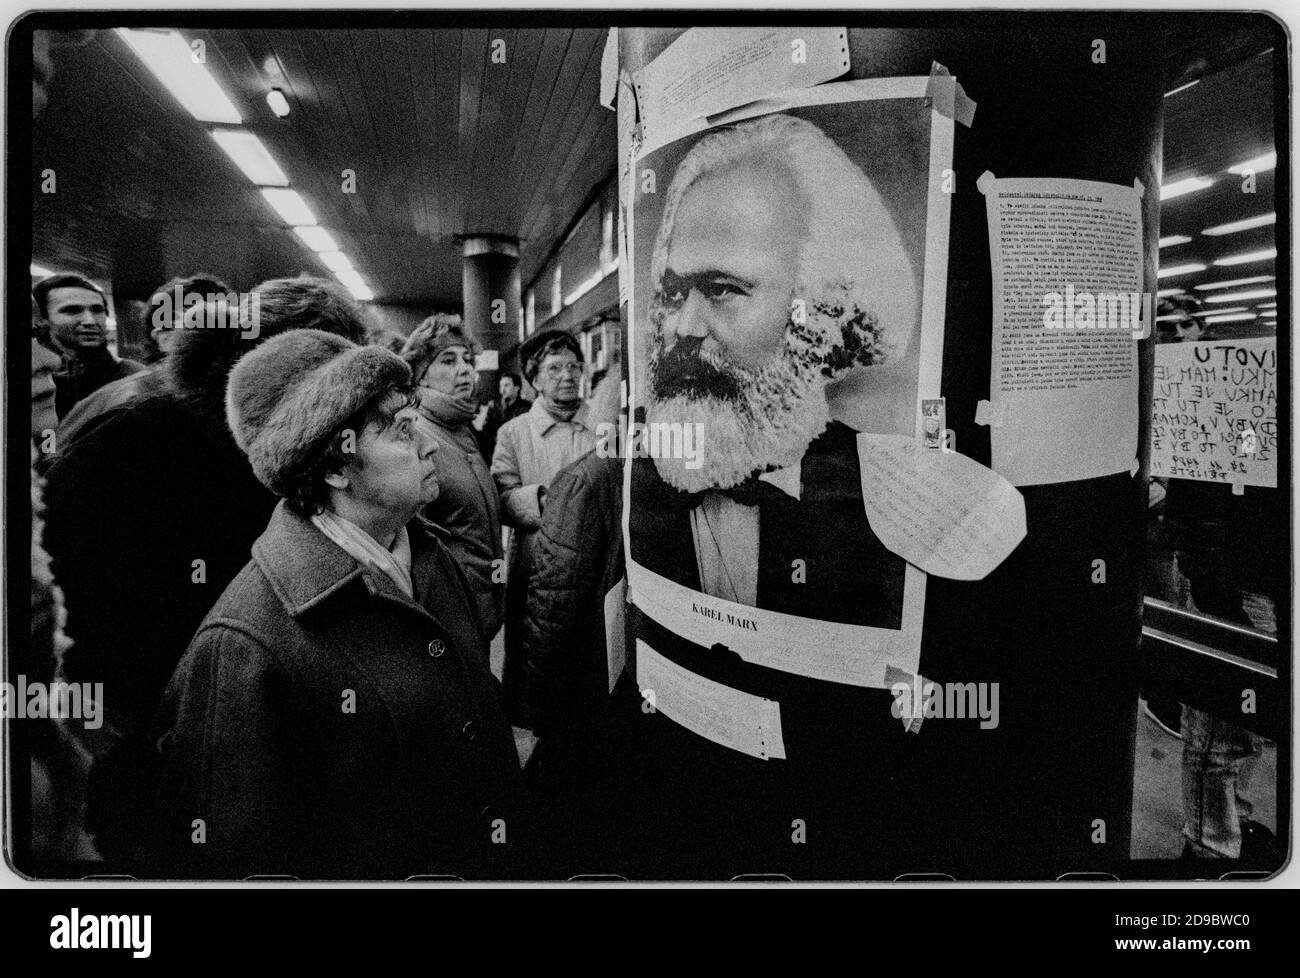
(1151, 337), (1278, 488)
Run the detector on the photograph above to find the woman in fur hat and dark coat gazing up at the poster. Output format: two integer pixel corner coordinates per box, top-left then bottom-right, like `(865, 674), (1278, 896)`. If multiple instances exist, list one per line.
(159, 329), (519, 878)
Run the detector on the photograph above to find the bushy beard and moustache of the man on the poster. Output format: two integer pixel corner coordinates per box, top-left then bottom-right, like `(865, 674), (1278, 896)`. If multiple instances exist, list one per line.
(646, 310), (831, 492)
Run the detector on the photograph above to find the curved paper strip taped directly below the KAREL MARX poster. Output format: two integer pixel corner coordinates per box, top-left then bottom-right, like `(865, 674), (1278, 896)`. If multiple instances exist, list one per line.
(637, 639), (785, 761)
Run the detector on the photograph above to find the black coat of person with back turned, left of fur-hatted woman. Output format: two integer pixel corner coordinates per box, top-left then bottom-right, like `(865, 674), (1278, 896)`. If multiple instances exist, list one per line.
(46, 330), (276, 731)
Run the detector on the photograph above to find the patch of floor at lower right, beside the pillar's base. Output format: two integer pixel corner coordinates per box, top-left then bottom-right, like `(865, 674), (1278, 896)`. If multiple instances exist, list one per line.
(1130, 709), (1278, 860)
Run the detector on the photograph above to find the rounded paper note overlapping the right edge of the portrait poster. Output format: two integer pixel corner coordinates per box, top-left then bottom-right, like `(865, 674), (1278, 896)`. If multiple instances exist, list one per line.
(858, 434), (1026, 580)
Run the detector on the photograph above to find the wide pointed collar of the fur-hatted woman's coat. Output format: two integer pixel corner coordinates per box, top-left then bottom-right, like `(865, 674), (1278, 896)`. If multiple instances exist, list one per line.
(252, 499), (447, 618)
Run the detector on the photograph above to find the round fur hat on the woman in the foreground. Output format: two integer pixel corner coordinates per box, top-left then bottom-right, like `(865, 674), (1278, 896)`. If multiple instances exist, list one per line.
(226, 329), (411, 496)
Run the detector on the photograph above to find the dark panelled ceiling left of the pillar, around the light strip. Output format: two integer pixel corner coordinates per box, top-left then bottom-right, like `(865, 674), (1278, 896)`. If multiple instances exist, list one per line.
(33, 25), (615, 306)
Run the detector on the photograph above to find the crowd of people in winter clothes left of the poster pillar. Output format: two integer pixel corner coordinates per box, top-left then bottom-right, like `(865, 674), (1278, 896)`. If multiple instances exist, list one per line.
(23, 274), (637, 878)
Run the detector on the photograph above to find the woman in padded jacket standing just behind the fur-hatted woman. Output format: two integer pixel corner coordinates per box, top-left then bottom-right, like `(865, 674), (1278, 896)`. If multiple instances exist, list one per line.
(402, 313), (506, 642)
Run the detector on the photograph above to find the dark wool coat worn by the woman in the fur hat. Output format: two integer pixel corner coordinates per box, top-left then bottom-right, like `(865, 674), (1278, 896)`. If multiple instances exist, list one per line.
(157, 505), (521, 878)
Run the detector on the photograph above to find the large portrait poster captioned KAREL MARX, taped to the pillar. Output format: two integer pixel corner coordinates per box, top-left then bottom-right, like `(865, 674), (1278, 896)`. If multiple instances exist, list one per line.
(625, 79), (952, 687)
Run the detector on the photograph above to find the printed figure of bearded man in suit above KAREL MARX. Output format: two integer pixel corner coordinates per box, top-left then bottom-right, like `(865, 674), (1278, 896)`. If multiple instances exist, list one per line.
(629, 114), (919, 628)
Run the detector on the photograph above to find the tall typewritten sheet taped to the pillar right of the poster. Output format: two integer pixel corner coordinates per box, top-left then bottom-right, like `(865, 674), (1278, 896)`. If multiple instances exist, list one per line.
(978, 173), (1151, 485)
